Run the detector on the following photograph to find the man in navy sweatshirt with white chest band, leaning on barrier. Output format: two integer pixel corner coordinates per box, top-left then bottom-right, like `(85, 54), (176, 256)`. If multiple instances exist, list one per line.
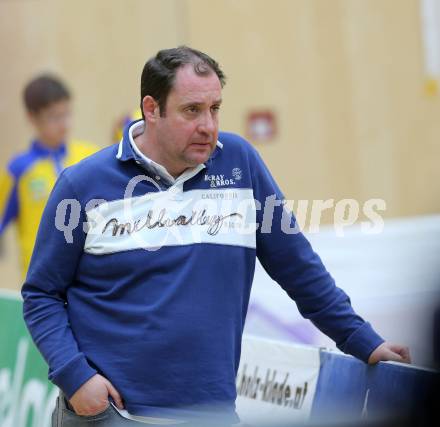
(22, 46), (409, 426)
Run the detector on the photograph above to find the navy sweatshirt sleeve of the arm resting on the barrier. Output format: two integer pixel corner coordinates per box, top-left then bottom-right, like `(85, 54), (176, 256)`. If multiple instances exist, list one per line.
(251, 147), (384, 362)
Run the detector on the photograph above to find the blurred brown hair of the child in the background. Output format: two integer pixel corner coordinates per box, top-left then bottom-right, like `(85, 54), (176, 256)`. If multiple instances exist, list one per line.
(23, 74), (70, 113)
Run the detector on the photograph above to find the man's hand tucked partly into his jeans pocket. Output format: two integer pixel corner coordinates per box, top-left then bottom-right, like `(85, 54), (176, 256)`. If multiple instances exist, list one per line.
(69, 374), (124, 415)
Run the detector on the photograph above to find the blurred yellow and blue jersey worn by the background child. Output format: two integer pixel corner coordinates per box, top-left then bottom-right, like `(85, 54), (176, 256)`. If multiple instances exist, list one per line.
(0, 140), (99, 275)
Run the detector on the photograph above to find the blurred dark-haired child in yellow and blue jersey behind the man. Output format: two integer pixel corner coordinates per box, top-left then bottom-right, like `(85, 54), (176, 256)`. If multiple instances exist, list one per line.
(0, 75), (99, 276)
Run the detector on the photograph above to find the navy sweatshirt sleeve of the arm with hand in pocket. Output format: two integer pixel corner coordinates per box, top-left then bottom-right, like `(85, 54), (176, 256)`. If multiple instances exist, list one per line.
(21, 169), (97, 399)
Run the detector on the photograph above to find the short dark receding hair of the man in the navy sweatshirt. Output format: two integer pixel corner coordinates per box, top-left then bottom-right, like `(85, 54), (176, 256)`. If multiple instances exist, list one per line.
(141, 46), (226, 120)
